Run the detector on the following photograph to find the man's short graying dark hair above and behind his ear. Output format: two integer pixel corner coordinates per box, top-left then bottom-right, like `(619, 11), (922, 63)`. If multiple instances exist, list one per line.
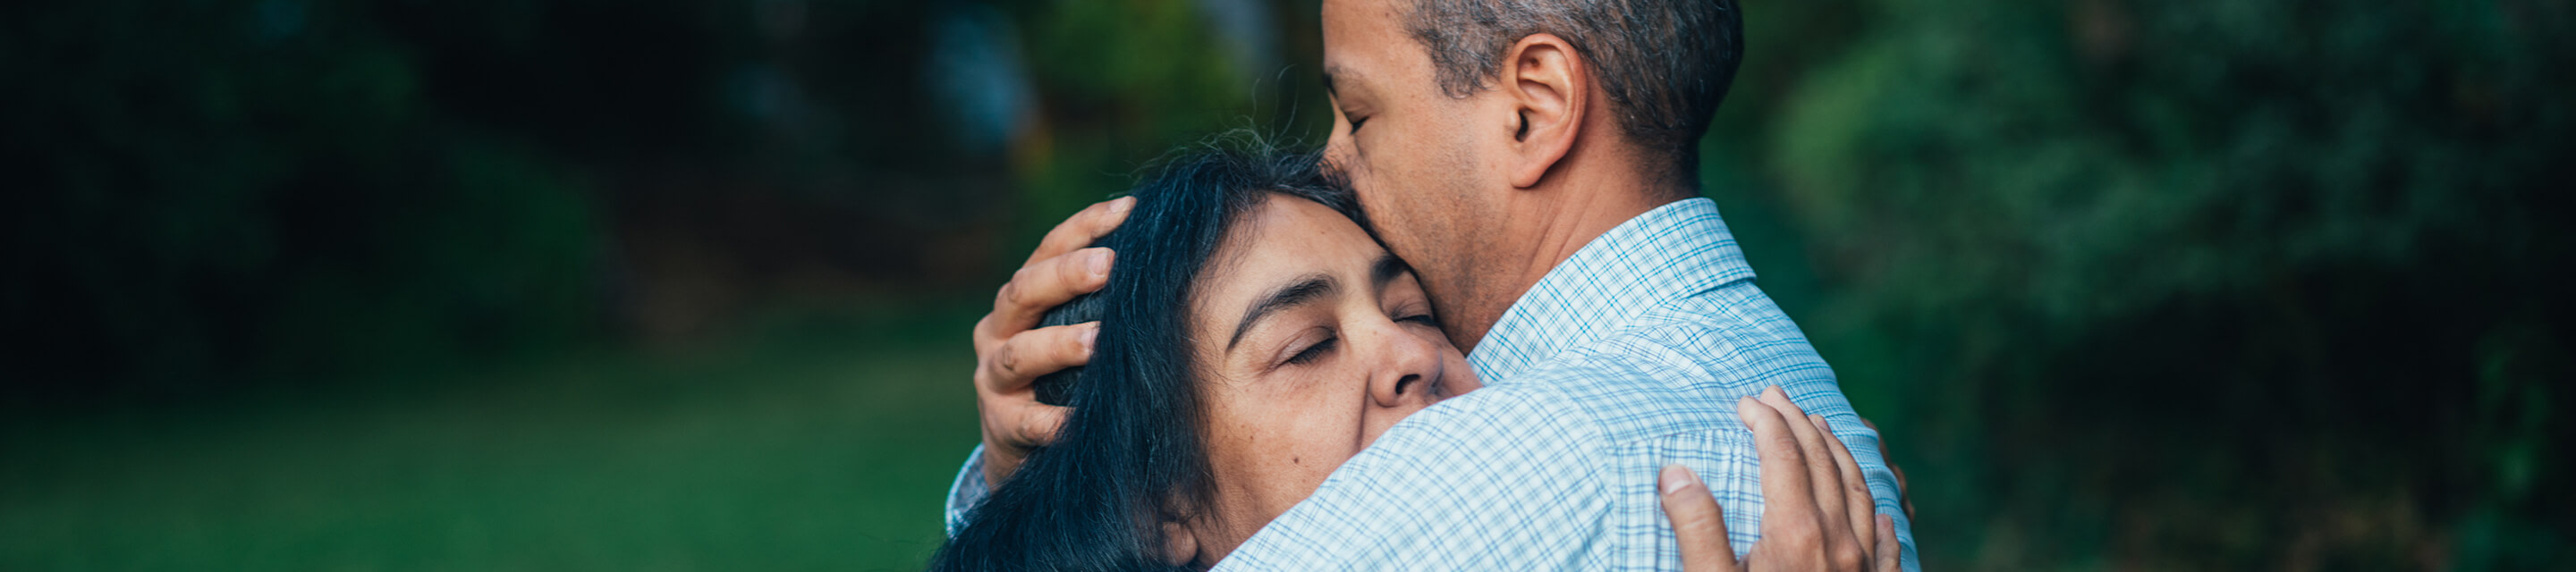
(1404, 0), (1744, 178)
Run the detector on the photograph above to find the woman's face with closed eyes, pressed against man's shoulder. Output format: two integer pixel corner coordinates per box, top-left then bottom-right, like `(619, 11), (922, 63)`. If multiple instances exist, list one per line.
(1188, 193), (1479, 561)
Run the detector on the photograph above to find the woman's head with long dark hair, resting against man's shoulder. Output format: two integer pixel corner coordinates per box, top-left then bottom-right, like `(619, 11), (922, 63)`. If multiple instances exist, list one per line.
(933, 144), (1476, 569)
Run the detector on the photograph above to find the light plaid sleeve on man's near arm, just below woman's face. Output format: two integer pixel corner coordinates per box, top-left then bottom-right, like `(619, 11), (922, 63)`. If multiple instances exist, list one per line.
(1216, 386), (1610, 572)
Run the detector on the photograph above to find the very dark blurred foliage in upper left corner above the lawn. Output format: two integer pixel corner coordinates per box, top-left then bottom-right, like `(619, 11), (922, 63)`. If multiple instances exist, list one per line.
(0, 3), (600, 400)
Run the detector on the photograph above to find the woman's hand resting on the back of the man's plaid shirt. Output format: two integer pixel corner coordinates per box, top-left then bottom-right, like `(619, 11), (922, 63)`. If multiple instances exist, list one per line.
(1657, 386), (1903, 572)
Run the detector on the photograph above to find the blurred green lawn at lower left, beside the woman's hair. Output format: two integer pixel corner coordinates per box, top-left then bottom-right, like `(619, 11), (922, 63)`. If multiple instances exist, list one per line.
(0, 307), (974, 569)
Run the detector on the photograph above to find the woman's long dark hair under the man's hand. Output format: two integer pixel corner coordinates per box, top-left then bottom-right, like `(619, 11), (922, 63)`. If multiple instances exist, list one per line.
(930, 137), (1368, 569)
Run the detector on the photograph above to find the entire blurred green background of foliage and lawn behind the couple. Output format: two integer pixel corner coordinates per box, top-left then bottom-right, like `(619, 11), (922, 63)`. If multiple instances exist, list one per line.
(0, 0), (2576, 569)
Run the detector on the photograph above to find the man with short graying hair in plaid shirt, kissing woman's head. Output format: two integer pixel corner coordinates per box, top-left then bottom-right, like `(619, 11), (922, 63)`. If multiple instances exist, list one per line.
(951, 0), (1917, 569)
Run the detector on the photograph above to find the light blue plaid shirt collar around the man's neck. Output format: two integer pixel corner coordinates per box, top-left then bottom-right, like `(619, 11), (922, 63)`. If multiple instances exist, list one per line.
(1466, 198), (1754, 384)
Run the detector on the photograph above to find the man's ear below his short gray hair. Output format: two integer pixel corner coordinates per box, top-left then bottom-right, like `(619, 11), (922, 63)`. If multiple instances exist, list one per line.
(1499, 33), (1592, 188)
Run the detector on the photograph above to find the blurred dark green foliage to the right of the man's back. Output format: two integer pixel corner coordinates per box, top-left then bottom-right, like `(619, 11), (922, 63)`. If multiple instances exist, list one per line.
(1757, 0), (2576, 569)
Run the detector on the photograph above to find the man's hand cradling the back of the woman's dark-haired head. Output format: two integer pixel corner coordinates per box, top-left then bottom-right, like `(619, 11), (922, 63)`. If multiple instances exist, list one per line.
(974, 196), (1136, 484)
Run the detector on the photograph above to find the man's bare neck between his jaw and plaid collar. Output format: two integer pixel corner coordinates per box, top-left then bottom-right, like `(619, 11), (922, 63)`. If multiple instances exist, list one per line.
(1445, 170), (1698, 350)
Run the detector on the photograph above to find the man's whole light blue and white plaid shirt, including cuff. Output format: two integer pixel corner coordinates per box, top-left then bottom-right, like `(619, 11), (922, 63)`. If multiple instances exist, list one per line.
(948, 198), (1919, 572)
